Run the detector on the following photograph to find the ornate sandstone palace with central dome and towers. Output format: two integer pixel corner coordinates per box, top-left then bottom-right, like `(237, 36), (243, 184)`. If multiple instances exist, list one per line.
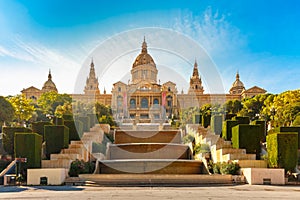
(21, 38), (266, 122)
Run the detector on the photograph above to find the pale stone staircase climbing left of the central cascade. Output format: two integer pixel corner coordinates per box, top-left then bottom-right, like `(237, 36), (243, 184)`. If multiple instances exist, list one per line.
(42, 124), (103, 170)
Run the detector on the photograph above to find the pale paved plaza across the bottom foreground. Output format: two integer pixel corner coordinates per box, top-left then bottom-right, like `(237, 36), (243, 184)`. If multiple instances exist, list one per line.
(0, 185), (300, 200)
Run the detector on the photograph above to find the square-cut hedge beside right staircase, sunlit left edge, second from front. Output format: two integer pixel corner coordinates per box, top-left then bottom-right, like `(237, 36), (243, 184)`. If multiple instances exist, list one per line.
(232, 124), (261, 159)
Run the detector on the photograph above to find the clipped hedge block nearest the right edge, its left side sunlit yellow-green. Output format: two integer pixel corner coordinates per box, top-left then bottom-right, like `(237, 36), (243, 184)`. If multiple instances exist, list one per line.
(267, 132), (298, 172)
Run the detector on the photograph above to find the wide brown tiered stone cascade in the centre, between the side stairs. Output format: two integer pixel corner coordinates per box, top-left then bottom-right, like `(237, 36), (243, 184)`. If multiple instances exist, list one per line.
(79, 127), (237, 186)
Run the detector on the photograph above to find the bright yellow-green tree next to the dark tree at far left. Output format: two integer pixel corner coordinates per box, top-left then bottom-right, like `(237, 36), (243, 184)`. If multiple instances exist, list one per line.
(8, 95), (35, 123)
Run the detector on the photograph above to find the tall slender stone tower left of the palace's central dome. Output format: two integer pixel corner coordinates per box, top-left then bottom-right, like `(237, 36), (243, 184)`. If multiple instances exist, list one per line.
(84, 60), (100, 95)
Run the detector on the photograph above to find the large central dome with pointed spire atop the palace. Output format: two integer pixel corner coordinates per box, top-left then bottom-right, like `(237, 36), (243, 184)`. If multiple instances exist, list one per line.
(131, 38), (157, 84)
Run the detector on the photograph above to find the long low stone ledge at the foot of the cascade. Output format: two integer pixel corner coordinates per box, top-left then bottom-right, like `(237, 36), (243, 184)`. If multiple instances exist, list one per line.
(76, 174), (233, 186)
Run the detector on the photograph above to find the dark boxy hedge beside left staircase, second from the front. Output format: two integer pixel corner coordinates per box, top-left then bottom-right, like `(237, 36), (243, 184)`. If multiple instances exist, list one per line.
(45, 126), (69, 159)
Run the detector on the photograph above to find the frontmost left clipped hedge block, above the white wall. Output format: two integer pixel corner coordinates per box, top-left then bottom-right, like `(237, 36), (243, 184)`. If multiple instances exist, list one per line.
(15, 133), (43, 168)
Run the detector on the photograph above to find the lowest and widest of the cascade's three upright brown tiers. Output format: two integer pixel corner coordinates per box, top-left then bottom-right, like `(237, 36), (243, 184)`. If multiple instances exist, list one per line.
(95, 159), (207, 174)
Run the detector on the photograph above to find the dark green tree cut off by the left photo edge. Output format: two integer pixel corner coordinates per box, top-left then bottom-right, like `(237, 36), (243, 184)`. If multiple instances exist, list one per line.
(0, 96), (14, 125)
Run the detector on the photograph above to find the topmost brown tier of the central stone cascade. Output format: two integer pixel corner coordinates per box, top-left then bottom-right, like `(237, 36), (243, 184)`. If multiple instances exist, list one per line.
(115, 130), (181, 144)
